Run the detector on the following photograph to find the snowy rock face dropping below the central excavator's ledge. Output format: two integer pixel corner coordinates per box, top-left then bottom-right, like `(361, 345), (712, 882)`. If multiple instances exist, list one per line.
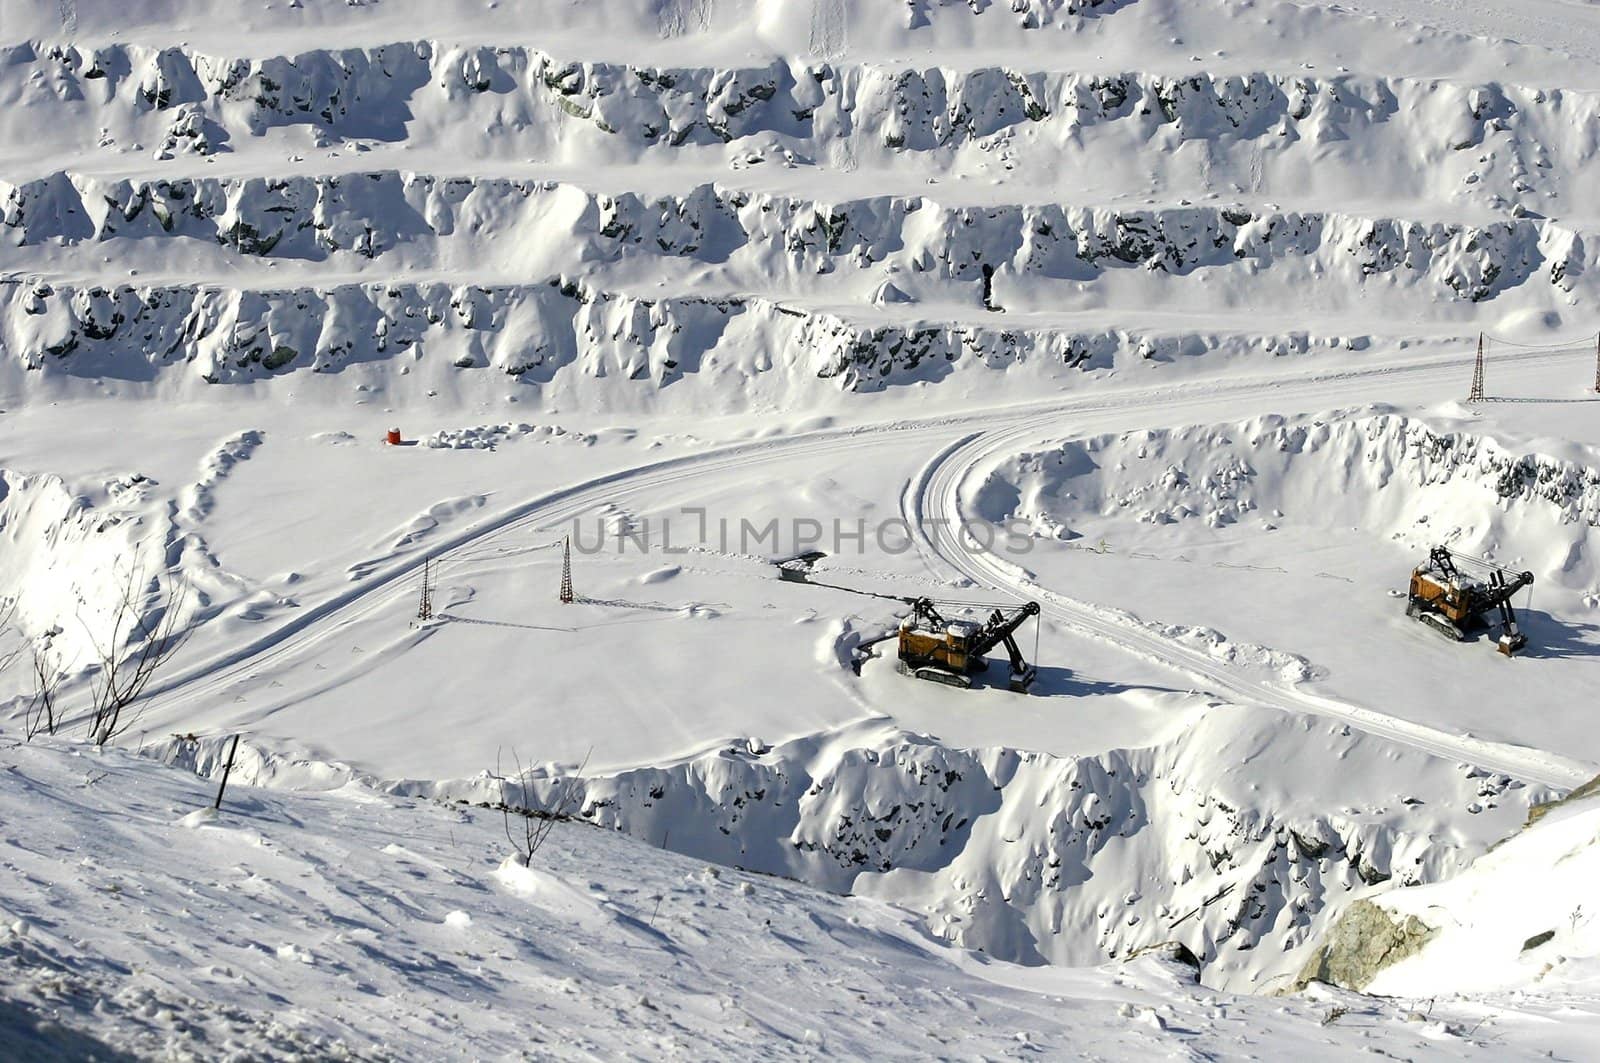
(470, 706), (1549, 989)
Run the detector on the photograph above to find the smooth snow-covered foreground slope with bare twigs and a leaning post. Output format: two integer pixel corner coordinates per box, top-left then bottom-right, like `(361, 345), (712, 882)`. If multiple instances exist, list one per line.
(12, 743), (1595, 1060)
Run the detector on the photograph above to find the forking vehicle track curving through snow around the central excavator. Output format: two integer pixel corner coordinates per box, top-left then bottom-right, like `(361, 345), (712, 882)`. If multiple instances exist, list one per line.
(146, 344), (1594, 789)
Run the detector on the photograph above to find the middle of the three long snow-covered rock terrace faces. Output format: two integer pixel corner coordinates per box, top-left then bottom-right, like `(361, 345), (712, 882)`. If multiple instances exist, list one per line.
(0, 171), (1587, 303)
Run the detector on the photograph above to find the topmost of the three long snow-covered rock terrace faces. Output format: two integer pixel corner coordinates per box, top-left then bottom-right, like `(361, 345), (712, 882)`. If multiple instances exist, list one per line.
(9, 43), (1600, 207)
